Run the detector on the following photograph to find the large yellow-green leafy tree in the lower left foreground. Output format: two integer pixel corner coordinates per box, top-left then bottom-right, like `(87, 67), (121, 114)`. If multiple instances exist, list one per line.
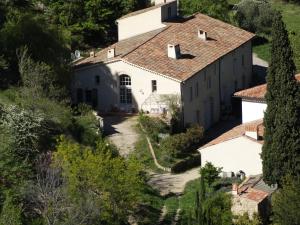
(54, 138), (144, 224)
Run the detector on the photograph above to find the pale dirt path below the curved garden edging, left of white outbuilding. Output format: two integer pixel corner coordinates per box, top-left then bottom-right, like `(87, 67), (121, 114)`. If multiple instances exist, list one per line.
(148, 167), (200, 196)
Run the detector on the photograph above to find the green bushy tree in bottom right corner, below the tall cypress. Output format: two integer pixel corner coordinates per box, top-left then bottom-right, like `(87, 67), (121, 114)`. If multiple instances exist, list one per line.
(272, 176), (300, 225)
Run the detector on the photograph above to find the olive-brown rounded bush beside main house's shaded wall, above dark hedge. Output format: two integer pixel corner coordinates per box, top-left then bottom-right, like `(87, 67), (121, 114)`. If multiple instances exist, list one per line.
(161, 126), (204, 158)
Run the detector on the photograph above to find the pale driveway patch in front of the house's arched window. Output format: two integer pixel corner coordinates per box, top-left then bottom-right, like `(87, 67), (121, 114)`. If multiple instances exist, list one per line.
(104, 116), (138, 157)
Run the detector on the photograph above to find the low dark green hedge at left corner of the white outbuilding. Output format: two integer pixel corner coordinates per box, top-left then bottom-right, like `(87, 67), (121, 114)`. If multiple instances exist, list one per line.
(171, 154), (201, 173)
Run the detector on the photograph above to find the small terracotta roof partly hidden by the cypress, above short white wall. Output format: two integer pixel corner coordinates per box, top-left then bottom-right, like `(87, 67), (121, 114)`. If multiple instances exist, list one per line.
(234, 74), (300, 101)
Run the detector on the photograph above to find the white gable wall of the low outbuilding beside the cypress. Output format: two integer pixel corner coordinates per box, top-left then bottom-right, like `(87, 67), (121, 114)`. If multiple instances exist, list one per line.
(200, 136), (262, 176)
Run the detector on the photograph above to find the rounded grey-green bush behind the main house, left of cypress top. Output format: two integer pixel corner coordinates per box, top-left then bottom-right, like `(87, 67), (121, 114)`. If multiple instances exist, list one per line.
(235, 0), (274, 34)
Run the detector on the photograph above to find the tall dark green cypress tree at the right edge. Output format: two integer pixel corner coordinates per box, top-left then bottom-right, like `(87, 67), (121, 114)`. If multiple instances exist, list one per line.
(262, 13), (300, 185)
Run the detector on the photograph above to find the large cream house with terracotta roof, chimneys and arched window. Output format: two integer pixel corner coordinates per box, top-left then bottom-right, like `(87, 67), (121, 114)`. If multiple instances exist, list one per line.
(73, 0), (254, 128)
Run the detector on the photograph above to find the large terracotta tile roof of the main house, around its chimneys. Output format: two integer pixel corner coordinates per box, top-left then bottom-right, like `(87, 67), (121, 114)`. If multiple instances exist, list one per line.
(76, 14), (254, 80)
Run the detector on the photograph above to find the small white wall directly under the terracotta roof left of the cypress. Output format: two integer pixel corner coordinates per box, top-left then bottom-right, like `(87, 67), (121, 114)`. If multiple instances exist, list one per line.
(242, 100), (267, 123)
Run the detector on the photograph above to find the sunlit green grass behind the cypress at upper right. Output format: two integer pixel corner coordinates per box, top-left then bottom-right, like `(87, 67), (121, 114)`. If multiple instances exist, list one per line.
(253, 0), (300, 72)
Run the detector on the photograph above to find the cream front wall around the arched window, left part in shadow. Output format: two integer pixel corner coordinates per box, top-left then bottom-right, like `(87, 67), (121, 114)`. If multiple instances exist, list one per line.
(73, 61), (180, 111)
